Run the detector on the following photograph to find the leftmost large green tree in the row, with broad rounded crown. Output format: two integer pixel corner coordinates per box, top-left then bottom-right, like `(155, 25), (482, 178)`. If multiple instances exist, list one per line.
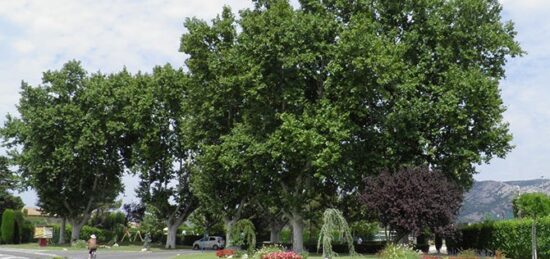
(2, 61), (124, 244)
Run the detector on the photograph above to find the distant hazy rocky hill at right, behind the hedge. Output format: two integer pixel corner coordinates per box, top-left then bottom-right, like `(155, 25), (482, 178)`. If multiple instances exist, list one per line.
(458, 179), (550, 222)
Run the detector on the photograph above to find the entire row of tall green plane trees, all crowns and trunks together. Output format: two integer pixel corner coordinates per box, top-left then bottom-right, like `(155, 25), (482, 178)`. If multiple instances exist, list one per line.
(1, 0), (522, 252)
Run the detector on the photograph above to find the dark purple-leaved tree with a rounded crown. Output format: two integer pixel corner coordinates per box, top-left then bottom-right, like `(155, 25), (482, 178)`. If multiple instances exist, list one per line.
(361, 167), (463, 241)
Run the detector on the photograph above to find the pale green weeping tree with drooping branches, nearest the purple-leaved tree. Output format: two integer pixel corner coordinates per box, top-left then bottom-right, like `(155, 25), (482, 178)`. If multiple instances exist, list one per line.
(317, 209), (357, 258)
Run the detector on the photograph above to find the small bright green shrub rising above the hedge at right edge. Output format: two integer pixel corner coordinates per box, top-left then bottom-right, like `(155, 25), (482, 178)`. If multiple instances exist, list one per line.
(512, 193), (550, 218)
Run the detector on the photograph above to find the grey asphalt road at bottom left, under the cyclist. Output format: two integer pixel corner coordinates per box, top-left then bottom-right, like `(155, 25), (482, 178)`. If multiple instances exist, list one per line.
(0, 248), (205, 259)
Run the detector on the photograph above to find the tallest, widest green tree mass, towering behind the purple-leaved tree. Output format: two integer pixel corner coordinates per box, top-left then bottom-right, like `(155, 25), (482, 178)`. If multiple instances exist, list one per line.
(180, 0), (522, 251)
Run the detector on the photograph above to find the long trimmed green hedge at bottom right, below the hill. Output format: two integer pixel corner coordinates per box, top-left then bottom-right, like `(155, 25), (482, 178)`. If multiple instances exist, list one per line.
(447, 217), (550, 259)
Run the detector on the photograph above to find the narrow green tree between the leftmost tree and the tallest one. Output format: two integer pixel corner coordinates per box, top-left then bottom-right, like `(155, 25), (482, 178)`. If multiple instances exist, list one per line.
(124, 65), (198, 248)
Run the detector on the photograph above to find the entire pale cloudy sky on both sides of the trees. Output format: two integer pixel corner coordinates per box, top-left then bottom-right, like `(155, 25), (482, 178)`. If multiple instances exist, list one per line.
(0, 0), (550, 206)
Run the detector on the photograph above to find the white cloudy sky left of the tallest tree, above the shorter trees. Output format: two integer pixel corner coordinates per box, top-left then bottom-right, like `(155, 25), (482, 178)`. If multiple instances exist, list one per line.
(0, 0), (251, 206)
